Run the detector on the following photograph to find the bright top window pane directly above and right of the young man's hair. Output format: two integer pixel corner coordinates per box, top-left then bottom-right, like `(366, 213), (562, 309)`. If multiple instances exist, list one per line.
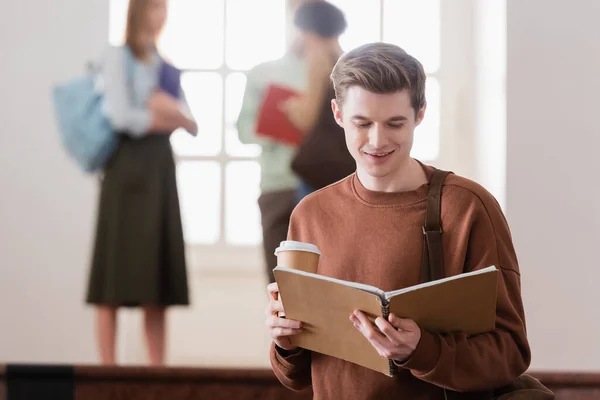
(383, 0), (440, 72)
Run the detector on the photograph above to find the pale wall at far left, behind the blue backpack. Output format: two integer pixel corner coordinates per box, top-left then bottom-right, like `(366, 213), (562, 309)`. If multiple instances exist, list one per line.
(0, 0), (108, 362)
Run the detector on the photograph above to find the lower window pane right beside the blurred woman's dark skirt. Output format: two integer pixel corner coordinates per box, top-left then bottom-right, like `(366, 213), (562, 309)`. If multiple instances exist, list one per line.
(177, 161), (221, 244)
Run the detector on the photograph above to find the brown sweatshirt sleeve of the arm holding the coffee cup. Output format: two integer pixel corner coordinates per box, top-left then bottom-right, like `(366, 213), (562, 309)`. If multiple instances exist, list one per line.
(270, 205), (312, 391)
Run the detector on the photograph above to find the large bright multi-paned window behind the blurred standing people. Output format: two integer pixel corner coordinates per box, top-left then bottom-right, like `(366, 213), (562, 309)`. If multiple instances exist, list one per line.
(110, 0), (444, 267)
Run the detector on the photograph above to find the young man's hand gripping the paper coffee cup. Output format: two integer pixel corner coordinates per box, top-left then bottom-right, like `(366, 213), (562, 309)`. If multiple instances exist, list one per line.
(265, 283), (302, 351)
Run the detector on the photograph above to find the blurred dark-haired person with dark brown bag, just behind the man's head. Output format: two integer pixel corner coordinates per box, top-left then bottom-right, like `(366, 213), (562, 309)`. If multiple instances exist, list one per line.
(283, 1), (356, 200)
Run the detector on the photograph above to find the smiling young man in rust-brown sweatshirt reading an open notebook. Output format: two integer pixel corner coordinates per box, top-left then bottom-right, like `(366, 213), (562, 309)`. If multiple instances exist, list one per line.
(267, 43), (530, 399)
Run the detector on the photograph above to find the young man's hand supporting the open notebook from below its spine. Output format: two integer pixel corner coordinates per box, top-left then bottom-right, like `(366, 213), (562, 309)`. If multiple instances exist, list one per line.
(350, 310), (421, 362)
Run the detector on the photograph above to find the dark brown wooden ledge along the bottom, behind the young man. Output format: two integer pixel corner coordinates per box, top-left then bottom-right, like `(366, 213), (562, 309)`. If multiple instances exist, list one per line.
(0, 365), (600, 400)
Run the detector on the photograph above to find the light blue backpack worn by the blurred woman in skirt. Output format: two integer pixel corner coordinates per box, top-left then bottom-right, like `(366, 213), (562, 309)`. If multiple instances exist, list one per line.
(52, 47), (134, 173)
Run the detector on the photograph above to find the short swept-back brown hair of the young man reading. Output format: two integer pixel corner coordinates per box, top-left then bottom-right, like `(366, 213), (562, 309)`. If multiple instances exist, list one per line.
(331, 43), (426, 113)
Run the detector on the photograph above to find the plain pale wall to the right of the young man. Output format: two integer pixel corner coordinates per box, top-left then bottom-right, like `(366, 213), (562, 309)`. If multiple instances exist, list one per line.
(507, 0), (600, 370)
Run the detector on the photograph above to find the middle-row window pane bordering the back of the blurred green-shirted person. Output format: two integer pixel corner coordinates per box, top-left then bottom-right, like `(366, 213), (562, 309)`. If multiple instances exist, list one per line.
(225, 72), (260, 157)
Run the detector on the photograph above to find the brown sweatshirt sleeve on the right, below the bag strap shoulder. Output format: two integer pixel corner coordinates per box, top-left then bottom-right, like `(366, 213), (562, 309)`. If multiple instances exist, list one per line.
(397, 188), (531, 392)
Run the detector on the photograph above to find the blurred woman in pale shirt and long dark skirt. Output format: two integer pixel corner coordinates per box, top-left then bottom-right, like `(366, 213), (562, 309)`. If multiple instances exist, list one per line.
(87, 0), (197, 365)
